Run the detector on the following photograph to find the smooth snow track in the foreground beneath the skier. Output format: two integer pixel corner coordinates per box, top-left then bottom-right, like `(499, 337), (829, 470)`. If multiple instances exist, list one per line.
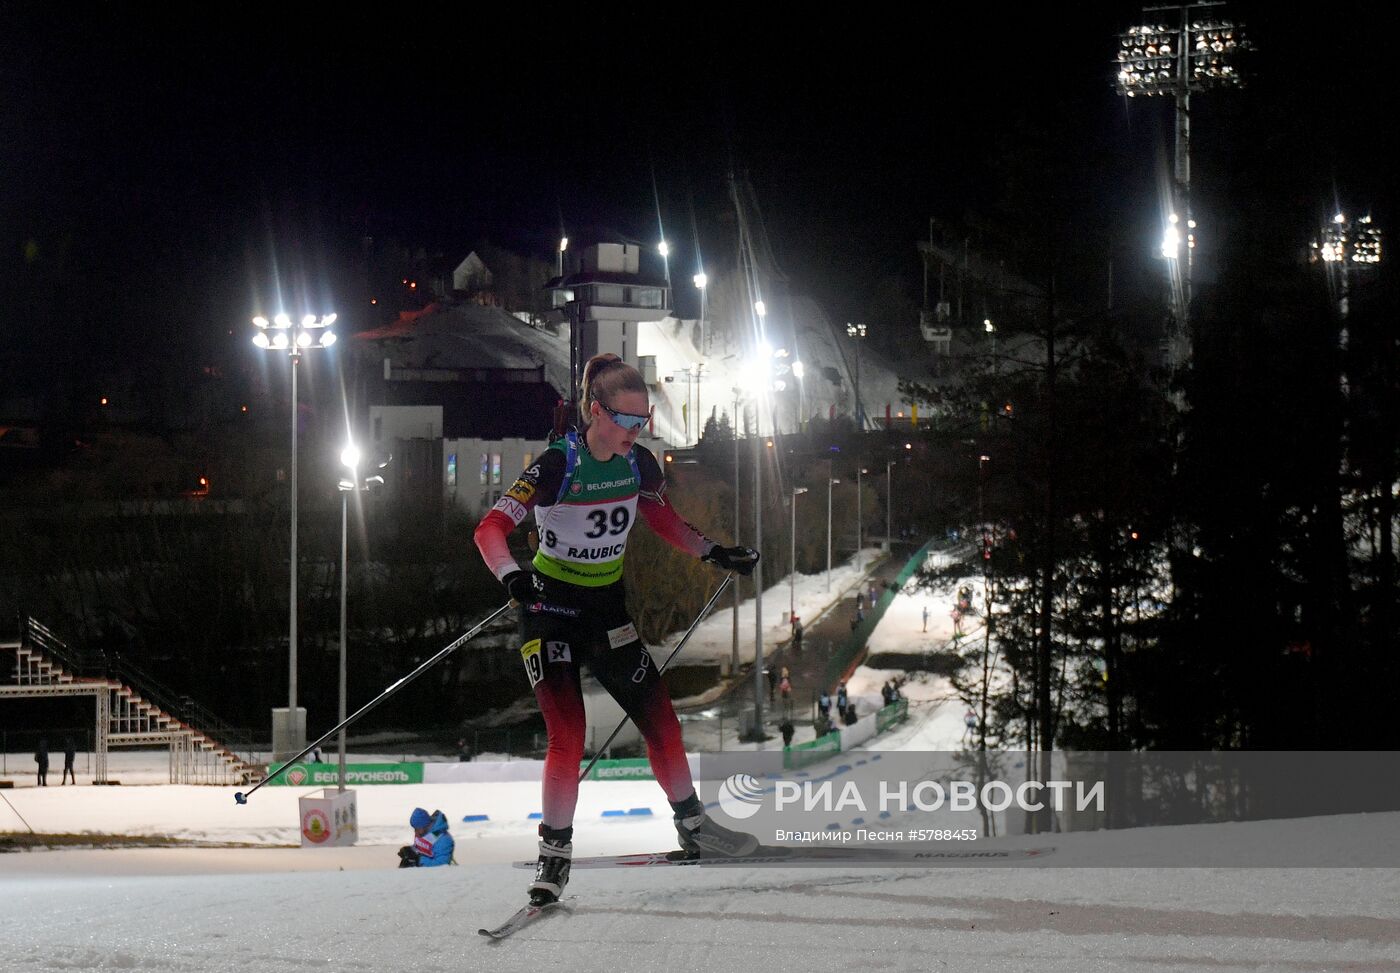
(0, 812), (1400, 973)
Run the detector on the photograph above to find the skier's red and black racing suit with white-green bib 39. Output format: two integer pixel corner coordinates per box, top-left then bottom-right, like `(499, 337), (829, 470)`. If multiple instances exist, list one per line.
(475, 433), (714, 829)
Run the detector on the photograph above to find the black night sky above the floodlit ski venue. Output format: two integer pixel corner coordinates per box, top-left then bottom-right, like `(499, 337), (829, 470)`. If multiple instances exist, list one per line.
(0, 3), (1396, 392)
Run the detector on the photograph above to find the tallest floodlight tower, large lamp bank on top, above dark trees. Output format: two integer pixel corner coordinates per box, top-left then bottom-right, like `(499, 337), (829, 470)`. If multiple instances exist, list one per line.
(1116, 8), (1249, 389)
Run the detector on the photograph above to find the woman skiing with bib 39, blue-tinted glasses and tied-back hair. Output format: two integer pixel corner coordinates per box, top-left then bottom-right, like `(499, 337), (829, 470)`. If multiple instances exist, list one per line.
(475, 354), (759, 904)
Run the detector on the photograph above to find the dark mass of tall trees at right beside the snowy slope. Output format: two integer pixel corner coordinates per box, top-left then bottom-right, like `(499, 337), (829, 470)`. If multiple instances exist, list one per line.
(910, 247), (1400, 767)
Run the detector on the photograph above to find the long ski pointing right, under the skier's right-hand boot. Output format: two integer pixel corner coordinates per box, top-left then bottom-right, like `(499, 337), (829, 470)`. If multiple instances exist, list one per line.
(515, 846), (1054, 869)
